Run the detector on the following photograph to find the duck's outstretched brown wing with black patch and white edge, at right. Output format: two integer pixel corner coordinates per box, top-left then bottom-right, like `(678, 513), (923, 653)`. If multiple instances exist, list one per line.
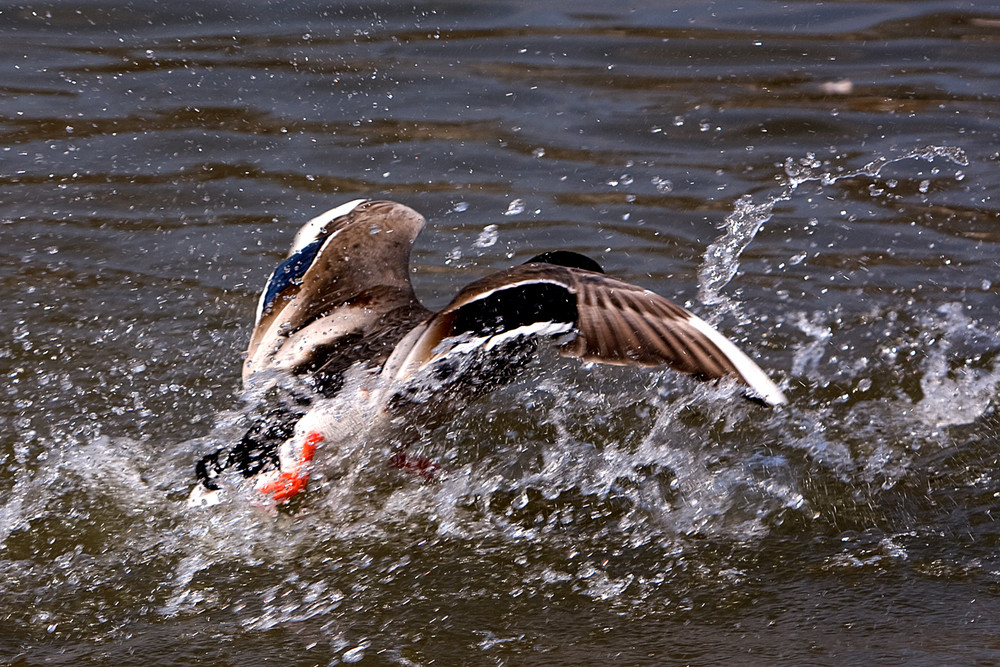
(384, 262), (787, 405)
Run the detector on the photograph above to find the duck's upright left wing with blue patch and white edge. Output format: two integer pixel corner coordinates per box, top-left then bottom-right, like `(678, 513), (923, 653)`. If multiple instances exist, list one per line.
(243, 199), (428, 381)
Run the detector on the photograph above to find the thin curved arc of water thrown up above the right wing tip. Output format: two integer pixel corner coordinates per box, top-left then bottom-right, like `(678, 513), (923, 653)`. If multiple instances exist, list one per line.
(698, 146), (969, 322)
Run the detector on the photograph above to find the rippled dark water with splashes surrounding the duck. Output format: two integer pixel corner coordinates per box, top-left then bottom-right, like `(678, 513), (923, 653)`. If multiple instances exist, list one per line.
(0, 2), (1000, 665)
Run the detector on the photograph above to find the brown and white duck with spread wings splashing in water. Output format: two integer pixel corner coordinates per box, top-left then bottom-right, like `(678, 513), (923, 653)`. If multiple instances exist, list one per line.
(189, 199), (787, 506)
